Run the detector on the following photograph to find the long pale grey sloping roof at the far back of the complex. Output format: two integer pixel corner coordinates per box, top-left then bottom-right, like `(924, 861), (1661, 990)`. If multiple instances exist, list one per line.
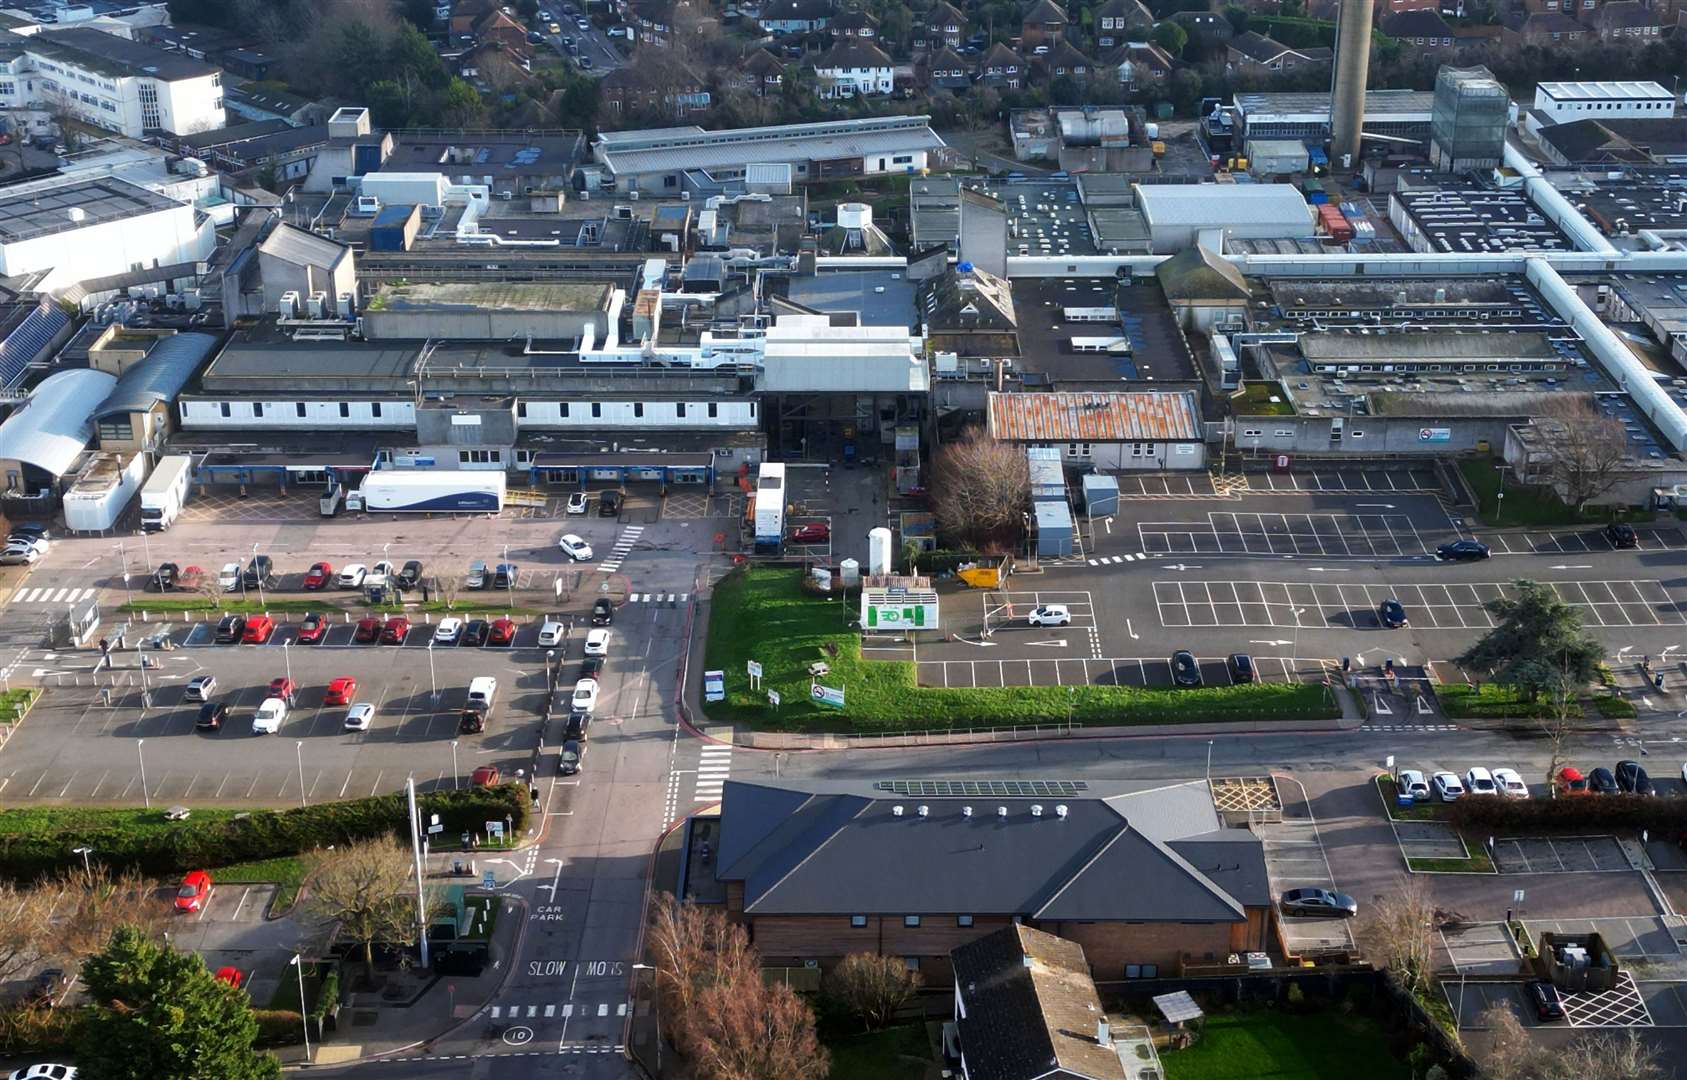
(596, 116), (945, 176)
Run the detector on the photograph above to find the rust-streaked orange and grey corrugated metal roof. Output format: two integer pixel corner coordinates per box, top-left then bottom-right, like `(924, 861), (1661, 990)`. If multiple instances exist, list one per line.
(990, 392), (1201, 442)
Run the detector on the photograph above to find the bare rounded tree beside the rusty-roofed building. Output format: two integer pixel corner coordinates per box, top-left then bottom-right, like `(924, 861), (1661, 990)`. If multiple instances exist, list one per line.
(931, 427), (1031, 547)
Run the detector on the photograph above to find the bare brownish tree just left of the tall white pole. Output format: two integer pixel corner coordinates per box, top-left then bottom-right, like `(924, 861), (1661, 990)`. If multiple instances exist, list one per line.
(300, 837), (417, 980)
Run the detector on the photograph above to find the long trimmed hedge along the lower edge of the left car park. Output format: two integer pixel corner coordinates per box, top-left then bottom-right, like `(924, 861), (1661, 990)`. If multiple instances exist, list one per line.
(0, 783), (528, 881)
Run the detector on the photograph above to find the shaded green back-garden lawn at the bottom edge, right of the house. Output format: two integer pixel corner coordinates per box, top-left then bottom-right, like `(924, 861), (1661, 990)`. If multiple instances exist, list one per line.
(1160, 1013), (1412, 1080)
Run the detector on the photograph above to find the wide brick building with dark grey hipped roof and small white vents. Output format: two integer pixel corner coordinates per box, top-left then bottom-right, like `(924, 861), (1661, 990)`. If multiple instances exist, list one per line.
(712, 776), (1272, 986)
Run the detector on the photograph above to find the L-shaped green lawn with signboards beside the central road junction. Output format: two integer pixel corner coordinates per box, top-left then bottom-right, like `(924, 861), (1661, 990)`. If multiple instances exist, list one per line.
(703, 567), (1339, 732)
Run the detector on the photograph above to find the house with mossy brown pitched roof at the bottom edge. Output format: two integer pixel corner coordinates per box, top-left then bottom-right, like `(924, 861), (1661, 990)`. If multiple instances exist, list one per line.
(950, 925), (1137, 1080)
